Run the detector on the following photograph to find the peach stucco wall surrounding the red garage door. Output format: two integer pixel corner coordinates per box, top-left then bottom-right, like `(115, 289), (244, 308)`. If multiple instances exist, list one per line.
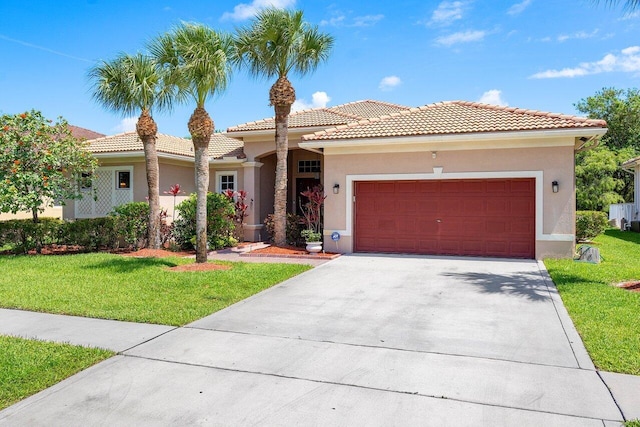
(324, 140), (575, 259)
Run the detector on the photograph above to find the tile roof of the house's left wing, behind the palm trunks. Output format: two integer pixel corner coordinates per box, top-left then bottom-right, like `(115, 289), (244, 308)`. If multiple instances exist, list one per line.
(88, 132), (244, 158)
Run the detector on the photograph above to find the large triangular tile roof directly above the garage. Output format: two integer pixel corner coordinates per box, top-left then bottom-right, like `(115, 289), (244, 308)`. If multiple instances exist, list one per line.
(303, 101), (607, 141)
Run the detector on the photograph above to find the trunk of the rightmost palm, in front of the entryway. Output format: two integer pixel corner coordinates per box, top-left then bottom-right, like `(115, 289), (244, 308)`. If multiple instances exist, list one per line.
(273, 105), (291, 246)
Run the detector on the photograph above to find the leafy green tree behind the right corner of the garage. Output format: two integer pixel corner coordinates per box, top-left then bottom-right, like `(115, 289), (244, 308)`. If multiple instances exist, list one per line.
(575, 88), (640, 210)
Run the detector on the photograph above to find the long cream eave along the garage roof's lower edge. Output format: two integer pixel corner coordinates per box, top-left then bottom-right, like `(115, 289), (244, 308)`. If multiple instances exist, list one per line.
(298, 127), (607, 148)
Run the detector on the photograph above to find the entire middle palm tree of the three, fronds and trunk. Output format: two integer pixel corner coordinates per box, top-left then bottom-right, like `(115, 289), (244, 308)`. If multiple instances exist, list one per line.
(149, 23), (233, 263)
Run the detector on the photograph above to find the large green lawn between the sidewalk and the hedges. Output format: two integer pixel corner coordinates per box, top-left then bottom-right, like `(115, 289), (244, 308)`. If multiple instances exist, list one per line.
(0, 253), (311, 326)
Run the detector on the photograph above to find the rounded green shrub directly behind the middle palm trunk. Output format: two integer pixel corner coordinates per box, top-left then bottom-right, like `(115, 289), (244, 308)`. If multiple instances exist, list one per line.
(173, 193), (237, 249)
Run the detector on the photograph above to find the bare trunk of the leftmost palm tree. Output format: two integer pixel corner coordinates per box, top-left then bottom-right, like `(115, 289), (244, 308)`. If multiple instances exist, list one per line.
(136, 109), (160, 249)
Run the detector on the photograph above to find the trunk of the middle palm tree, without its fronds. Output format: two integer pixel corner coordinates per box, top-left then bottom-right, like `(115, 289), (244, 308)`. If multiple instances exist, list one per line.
(188, 107), (214, 263)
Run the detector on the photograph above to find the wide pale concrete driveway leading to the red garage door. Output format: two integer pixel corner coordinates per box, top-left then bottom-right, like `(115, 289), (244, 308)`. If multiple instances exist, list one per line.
(0, 255), (622, 426)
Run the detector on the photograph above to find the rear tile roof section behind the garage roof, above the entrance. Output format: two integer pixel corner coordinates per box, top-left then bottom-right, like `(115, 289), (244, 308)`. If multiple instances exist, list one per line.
(227, 100), (409, 133)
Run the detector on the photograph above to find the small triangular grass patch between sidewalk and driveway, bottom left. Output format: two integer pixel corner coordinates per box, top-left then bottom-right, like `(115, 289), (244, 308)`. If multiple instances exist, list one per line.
(0, 336), (114, 410)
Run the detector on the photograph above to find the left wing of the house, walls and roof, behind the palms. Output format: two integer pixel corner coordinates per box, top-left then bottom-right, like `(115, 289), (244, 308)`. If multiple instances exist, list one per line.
(63, 132), (245, 218)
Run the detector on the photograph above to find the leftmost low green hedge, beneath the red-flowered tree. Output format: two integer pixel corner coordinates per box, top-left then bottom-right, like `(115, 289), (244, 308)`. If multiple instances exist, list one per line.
(0, 218), (64, 253)
